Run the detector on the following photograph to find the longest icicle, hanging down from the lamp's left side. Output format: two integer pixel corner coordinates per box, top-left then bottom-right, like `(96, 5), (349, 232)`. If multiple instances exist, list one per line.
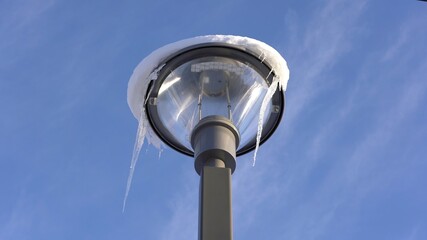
(122, 109), (147, 212)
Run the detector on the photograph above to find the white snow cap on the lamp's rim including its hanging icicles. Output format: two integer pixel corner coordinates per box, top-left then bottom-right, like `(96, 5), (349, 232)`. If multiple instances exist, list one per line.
(124, 35), (289, 211)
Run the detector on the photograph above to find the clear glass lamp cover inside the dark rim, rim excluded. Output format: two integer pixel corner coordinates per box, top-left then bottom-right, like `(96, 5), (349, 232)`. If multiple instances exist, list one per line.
(157, 57), (272, 150)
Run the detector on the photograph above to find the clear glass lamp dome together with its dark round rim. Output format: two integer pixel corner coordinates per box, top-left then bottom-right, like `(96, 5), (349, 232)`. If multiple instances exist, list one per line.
(147, 45), (283, 155)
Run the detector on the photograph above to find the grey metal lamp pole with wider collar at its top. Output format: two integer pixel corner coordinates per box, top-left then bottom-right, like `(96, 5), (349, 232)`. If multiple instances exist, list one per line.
(191, 116), (240, 240)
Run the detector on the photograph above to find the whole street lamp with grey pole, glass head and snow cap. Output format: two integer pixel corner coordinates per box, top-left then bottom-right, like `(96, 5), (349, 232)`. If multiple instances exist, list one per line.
(128, 35), (288, 240)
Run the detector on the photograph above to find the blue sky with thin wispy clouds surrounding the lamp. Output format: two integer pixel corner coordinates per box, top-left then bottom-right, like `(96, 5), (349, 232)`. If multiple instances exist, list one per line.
(0, 0), (427, 240)
